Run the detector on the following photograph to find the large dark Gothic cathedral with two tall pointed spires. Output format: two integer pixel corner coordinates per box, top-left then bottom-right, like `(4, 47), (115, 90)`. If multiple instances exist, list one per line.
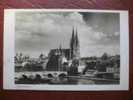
(46, 29), (80, 71)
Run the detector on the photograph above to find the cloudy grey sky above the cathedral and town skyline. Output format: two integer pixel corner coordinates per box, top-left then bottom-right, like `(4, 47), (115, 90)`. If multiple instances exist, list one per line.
(15, 11), (120, 57)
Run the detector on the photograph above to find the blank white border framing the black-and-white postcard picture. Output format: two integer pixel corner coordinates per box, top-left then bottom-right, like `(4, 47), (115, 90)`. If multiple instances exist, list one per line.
(3, 9), (129, 91)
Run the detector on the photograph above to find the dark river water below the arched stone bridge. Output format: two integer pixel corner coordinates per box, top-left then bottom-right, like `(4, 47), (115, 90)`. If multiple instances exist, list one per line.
(15, 77), (119, 85)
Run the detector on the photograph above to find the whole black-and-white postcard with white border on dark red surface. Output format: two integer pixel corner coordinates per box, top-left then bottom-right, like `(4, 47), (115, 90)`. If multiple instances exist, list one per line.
(4, 9), (129, 90)
